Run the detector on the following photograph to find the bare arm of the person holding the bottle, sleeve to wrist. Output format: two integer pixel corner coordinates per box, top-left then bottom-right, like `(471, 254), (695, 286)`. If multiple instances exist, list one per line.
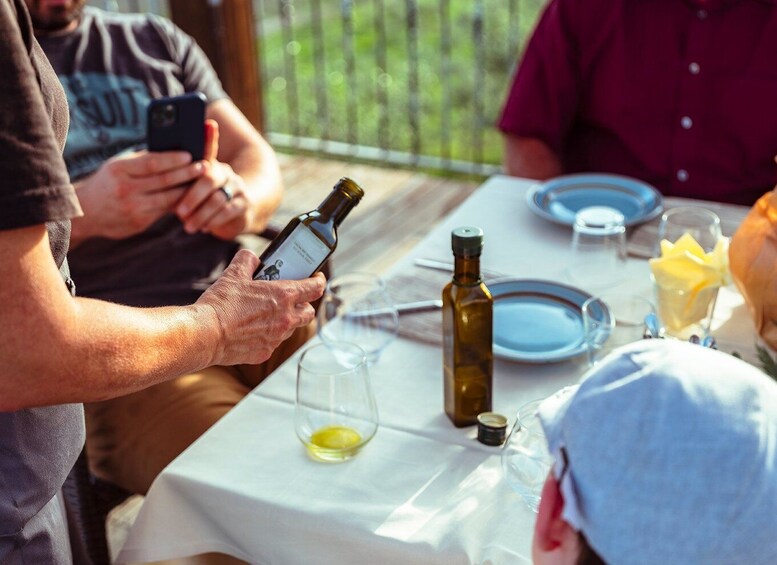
(0, 224), (220, 411)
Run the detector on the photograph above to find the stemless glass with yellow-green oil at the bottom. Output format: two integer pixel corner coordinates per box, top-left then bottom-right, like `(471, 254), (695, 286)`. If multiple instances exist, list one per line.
(294, 342), (378, 462)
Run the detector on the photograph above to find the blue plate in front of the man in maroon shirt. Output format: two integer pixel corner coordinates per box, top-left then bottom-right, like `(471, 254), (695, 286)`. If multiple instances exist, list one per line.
(526, 173), (664, 226)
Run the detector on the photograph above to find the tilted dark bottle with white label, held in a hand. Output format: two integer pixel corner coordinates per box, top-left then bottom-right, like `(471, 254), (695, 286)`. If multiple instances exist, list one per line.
(254, 177), (364, 281)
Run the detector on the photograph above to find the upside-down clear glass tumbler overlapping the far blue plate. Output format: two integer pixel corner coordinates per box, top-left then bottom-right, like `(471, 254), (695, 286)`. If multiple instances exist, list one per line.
(567, 206), (626, 291)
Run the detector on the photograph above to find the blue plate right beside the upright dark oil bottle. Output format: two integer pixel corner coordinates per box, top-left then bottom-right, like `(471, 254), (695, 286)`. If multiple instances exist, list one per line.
(488, 279), (610, 363)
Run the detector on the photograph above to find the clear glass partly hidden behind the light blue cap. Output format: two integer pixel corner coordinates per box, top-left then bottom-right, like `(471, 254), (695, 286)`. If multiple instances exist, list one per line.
(502, 399), (553, 512)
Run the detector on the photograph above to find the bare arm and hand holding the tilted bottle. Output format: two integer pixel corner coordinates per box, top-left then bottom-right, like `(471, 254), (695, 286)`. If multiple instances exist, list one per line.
(0, 225), (324, 411)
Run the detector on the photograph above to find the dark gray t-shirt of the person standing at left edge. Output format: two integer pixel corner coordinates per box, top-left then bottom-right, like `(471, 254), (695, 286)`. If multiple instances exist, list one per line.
(0, 0), (84, 564)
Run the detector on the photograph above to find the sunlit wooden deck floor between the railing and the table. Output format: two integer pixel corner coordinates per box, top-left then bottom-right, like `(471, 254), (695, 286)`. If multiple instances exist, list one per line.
(275, 154), (480, 274)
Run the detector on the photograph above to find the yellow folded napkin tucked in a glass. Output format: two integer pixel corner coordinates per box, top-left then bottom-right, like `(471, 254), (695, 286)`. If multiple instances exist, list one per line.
(650, 234), (731, 331)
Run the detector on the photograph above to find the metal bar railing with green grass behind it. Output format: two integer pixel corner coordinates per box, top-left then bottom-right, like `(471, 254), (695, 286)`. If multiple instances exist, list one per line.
(90, 0), (545, 175)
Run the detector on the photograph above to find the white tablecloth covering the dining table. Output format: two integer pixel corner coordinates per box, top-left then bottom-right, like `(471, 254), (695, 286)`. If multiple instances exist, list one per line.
(117, 175), (757, 565)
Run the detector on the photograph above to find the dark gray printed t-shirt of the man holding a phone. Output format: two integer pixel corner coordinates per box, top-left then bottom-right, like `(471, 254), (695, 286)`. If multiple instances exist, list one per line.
(40, 7), (238, 306)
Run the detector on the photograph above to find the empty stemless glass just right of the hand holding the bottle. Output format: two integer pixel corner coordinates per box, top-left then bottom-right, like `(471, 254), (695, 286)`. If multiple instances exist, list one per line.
(318, 273), (399, 364)
